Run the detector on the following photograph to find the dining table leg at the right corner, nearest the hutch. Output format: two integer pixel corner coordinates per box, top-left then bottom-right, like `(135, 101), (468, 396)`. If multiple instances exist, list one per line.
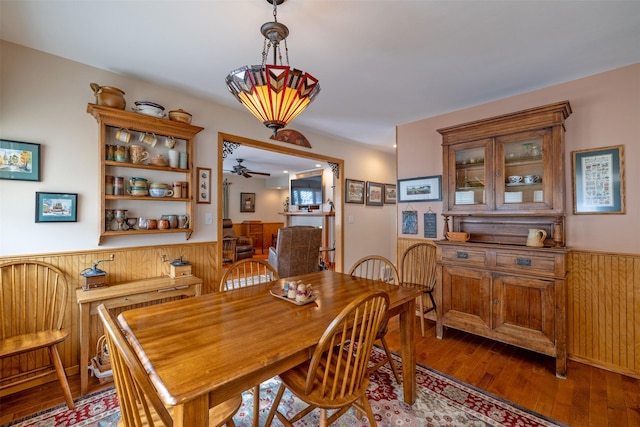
(400, 298), (416, 405)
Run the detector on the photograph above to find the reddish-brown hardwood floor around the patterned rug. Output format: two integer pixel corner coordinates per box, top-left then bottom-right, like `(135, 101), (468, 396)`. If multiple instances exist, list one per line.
(0, 318), (640, 427)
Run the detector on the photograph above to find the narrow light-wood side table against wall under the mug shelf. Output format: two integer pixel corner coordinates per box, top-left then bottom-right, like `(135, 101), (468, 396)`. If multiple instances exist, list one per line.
(76, 276), (202, 396)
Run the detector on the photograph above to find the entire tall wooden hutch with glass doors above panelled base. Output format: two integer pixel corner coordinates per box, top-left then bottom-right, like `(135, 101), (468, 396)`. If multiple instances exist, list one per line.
(436, 101), (571, 377)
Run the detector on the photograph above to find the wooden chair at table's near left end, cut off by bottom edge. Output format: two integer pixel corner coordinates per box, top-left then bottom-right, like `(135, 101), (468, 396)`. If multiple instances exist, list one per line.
(98, 304), (242, 427)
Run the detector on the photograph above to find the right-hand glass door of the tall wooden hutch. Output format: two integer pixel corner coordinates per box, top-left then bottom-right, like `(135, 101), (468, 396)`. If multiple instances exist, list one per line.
(496, 131), (551, 209)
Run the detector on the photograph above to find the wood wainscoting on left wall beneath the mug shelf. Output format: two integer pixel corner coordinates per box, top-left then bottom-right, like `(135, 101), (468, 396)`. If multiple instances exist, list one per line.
(0, 242), (221, 391)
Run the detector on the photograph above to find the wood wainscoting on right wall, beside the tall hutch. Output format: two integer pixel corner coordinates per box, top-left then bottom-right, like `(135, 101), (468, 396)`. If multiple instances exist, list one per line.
(397, 238), (640, 378)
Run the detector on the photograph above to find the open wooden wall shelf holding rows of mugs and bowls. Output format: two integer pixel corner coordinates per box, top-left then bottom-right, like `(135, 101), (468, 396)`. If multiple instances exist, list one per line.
(87, 104), (204, 244)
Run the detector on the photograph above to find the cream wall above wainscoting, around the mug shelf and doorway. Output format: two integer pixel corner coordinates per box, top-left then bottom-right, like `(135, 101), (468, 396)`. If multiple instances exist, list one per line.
(0, 41), (396, 267)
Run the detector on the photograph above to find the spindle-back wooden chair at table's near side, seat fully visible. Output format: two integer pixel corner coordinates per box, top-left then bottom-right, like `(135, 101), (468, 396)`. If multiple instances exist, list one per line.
(265, 291), (389, 427)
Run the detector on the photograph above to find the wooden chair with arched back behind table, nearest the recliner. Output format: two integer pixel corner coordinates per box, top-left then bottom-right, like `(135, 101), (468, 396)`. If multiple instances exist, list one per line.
(220, 258), (280, 426)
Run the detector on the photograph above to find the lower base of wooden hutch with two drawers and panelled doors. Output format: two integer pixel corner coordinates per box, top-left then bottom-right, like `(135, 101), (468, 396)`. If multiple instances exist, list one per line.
(436, 241), (569, 378)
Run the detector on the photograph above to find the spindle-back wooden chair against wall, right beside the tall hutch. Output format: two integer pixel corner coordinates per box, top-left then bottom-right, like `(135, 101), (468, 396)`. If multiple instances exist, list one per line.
(400, 241), (436, 337)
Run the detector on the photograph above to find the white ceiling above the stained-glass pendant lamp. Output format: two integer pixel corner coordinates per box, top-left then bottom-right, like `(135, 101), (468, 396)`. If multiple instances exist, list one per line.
(0, 0), (640, 173)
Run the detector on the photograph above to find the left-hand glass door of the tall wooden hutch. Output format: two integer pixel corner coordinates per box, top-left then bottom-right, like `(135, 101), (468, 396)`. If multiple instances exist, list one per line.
(450, 140), (493, 210)
